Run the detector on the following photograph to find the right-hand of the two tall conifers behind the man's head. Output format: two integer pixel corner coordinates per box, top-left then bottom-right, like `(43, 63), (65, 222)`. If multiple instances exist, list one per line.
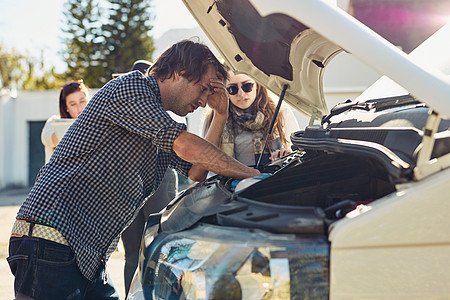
(102, 0), (155, 78)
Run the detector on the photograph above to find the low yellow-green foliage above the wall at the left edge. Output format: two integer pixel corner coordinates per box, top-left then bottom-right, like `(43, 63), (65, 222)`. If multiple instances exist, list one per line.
(0, 45), (64, 90)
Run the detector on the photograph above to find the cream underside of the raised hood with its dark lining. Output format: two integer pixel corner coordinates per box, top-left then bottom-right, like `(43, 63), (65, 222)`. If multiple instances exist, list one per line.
(184, 0), (342, 117)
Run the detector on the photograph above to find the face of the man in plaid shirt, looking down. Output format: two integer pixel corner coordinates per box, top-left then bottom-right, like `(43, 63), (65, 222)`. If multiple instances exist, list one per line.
(168, 65), (217, 116)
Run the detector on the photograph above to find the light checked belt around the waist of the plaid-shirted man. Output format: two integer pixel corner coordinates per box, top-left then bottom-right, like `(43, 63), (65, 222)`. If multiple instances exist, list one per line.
(11, 220), (69, 246)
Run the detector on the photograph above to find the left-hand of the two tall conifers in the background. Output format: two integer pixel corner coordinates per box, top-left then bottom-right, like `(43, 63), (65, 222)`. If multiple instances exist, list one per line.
(62, 0), (110, 87)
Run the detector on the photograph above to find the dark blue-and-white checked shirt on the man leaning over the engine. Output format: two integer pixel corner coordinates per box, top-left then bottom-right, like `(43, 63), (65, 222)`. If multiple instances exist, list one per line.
(17, 71), (191, 280)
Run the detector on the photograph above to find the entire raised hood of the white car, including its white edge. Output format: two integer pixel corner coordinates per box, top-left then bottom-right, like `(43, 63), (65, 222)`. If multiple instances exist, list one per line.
(183, 0), (450, 119)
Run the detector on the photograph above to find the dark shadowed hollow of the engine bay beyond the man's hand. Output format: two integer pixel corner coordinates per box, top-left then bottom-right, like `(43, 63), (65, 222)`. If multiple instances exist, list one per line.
(239, 151), (395, 209)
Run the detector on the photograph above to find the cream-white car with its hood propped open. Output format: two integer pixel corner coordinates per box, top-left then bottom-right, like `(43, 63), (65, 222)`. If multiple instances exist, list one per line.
(128, 0), (450, 299)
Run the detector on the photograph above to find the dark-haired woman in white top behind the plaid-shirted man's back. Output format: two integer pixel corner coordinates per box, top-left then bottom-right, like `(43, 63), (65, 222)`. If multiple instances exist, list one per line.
(41, 80), (89, 163)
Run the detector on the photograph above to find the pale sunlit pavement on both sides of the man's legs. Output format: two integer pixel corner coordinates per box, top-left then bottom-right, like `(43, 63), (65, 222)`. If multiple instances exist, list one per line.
(0, 188), (125, 299)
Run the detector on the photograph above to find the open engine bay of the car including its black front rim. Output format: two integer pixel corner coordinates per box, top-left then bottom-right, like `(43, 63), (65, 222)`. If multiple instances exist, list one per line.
(174, 150), (395, 235)
